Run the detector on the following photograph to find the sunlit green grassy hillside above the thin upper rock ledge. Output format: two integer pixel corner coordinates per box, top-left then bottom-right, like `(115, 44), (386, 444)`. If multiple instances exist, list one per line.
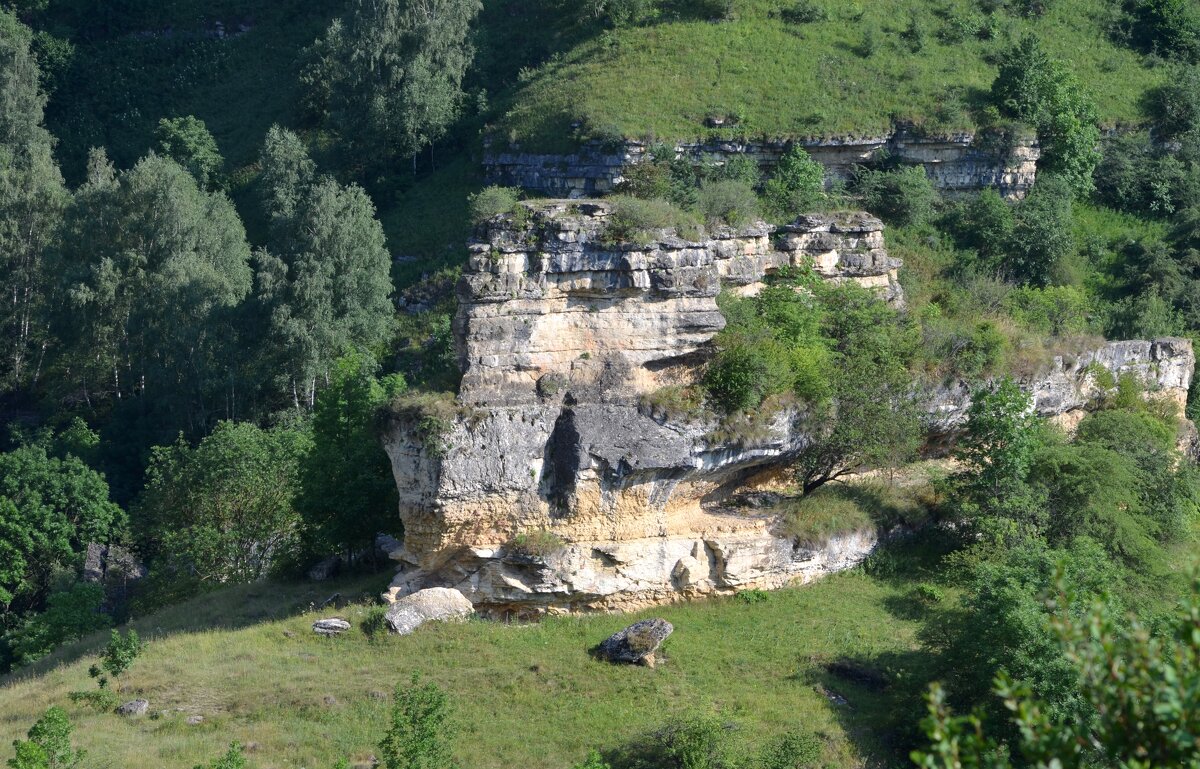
(494, 0), (1162, 151)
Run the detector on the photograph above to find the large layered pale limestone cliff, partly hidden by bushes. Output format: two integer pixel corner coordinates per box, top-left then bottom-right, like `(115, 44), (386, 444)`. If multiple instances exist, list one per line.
(384, 202), (1194, 611)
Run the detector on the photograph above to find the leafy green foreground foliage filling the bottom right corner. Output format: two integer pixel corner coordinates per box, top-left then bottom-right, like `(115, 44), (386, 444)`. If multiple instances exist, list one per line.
(913, 581), (1200, 769)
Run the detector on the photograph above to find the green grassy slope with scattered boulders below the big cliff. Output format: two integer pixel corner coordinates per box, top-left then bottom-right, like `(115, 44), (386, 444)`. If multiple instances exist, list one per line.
(0, 571), (936, 769)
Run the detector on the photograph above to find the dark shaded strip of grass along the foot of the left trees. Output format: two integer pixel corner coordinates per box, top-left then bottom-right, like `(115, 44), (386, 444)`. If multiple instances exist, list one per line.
(0, 571), (391, 686)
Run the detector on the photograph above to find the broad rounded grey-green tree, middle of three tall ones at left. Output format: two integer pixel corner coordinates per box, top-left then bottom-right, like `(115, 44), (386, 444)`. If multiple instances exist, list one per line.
(54, 154), (251, 429)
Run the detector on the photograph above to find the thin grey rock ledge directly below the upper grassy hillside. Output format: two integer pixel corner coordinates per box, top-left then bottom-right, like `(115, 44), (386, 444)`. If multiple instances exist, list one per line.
(484, 128), (1040, 198)
